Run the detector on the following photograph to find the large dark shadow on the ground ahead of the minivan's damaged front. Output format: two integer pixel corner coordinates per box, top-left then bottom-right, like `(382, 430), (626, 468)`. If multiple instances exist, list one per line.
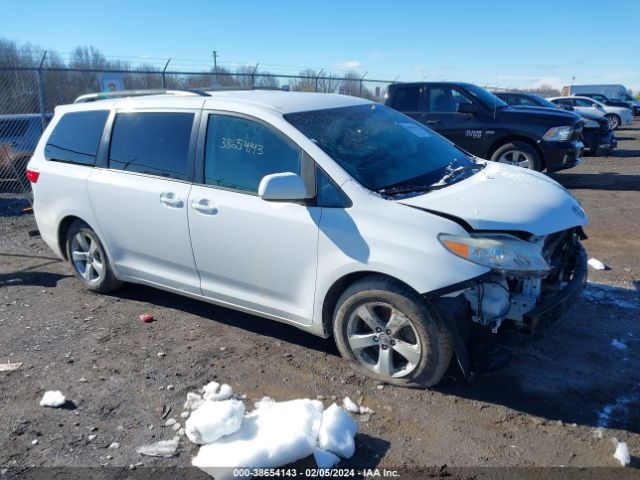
(435, 283), (640, 433)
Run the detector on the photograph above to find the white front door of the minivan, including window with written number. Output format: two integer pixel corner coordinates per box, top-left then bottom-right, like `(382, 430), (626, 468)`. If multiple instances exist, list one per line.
(188, 114), (321, 324)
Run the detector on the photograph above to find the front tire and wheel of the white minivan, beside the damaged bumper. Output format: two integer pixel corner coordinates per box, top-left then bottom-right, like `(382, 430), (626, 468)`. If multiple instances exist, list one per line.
(333, 276), (453, 388)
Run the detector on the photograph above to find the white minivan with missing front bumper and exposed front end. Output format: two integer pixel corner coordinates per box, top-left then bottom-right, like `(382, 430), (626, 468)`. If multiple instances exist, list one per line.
(27, 90), (587, 387)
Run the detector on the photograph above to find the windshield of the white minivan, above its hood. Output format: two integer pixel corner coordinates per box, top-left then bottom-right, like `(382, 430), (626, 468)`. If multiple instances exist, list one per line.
(284, 104), (476, 191)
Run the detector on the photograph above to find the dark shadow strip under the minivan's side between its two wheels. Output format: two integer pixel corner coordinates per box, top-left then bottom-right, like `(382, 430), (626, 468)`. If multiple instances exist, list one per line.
(111, 284), (340, 356)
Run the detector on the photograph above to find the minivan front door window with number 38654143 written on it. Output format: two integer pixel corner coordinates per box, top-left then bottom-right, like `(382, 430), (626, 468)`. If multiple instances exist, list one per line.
(204, 115), (302, 194)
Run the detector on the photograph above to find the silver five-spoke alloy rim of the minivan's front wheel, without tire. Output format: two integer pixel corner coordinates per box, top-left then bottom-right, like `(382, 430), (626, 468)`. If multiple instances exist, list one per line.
(347, 302), (422, 377)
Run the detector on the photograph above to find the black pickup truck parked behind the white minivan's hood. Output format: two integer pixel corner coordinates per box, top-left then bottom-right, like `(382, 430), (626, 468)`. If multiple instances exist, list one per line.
(385, 82), (584, 172)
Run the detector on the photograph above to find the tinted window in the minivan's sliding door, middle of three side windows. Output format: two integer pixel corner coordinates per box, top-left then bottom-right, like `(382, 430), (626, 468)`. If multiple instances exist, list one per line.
(109, 112), (194, 180)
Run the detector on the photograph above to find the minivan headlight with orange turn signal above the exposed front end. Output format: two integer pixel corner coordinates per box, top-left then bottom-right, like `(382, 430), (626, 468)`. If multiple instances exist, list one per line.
(438, 234), (551, 276)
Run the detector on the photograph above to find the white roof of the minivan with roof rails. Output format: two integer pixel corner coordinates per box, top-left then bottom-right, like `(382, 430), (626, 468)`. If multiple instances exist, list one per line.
(63, 89), (372, 114)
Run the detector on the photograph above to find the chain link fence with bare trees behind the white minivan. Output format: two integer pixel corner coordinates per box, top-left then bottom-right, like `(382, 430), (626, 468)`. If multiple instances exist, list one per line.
(0, 65), (391, 199)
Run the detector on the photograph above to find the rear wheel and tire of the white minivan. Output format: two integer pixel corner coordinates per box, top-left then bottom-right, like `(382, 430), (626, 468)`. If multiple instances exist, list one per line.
(66, 220), (122, 293)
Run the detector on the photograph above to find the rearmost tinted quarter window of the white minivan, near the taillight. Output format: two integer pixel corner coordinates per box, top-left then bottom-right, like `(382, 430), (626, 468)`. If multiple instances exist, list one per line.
(44, 110), (109, 165)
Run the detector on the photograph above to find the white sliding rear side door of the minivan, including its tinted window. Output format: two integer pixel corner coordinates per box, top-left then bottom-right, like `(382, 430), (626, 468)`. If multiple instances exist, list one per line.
(88, 111), (200, 293)
